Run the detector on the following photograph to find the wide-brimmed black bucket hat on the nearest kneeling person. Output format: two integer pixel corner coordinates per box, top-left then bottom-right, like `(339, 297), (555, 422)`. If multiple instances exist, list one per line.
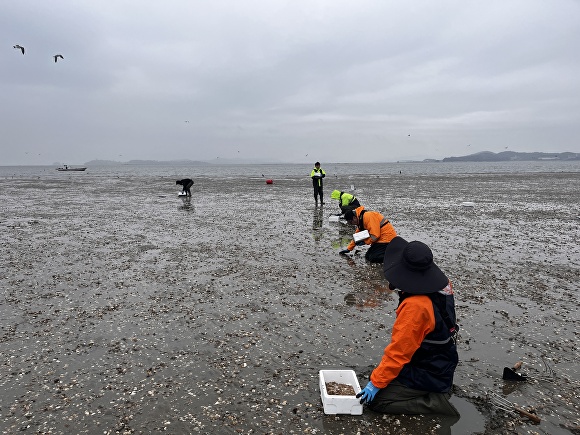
(383, 236), (449, 295)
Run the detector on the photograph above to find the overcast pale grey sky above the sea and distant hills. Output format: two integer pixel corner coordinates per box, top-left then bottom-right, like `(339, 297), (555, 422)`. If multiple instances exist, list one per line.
(0, 0), (580, 165)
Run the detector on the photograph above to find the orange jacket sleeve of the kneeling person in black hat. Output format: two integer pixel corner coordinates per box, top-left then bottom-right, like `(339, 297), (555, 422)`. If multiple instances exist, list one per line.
(371, 295), (435, 388)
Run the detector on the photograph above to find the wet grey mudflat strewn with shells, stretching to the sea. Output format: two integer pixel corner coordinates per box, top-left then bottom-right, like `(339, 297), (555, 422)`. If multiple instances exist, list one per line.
(0, 169), (580, 434)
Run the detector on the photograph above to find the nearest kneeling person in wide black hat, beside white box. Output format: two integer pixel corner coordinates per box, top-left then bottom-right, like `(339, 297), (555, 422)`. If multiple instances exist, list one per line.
(357, 237), (459, 417)
